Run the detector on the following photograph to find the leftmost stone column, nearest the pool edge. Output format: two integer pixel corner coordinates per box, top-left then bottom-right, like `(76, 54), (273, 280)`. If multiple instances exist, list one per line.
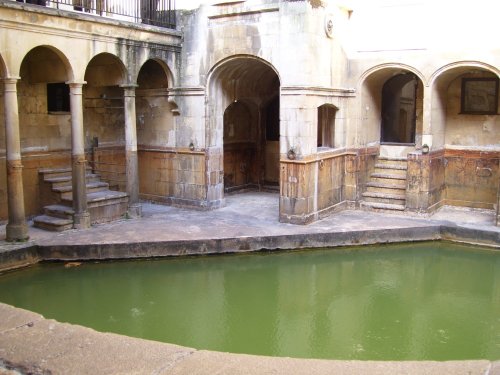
(3, 78), (29, 241)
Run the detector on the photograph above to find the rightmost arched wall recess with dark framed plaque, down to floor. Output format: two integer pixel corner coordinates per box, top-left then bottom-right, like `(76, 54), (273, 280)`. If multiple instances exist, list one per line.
(430, 61), (500, 209)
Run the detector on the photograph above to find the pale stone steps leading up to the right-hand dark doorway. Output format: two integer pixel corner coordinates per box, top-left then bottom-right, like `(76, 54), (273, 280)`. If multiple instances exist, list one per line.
(360, 157), (407, 213)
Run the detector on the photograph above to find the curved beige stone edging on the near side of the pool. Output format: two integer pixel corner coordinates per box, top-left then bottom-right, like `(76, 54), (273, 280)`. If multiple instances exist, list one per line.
(0, 303), (500, 375)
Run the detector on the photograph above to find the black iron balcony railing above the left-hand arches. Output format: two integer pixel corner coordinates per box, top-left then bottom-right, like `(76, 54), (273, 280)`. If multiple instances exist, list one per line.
(15, 0), (175, 29)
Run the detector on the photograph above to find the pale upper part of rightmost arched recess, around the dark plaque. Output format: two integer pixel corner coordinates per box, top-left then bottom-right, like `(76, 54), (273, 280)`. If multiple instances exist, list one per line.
(430, 60), (500, 149)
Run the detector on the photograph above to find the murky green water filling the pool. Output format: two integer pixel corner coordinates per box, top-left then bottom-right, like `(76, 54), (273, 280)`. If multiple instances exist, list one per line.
(0, 242), (500, 360)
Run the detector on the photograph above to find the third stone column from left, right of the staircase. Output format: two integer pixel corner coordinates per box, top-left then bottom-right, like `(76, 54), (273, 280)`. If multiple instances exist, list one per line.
(122, 85), (142, 217)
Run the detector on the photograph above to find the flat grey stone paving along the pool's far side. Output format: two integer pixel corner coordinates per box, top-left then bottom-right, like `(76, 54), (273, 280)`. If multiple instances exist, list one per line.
(0, 192), (500, 249)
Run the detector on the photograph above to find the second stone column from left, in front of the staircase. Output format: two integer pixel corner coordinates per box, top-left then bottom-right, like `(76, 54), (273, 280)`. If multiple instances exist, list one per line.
(68, 82), (90, 229)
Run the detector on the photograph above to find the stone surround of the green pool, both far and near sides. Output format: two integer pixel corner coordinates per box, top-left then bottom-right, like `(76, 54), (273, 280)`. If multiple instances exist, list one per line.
(0, 192), (500, 375)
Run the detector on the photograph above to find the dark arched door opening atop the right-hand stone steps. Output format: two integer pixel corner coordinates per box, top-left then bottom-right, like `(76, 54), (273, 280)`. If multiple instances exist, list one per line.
(380, 73), (418, 145)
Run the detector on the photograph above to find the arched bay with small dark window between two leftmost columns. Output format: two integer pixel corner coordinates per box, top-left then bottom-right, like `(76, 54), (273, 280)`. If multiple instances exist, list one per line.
(17, 46), (72, 216)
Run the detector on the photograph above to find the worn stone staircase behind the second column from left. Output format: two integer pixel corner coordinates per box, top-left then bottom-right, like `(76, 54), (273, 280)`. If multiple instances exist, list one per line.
(33, 168), (128, 232)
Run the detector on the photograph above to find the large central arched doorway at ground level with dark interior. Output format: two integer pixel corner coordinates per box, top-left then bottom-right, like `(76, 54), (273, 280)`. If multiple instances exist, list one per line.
(208, 56), (280, 197)
